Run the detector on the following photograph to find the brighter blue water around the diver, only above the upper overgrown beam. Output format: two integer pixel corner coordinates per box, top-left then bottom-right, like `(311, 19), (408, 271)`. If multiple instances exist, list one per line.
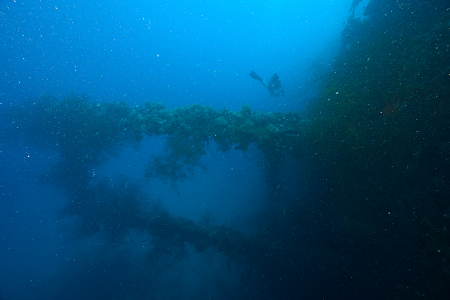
(1, 0), (362, 111)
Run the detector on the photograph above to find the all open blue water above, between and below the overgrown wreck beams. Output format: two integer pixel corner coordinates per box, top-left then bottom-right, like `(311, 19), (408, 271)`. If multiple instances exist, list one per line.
(0, 0), (366, 299)
